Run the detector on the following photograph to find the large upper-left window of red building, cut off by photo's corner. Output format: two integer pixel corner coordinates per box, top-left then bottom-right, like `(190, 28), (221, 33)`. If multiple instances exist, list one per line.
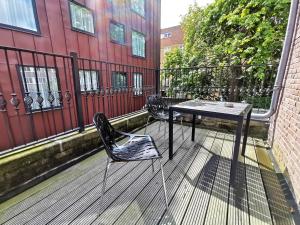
(0, 0), (39, 32)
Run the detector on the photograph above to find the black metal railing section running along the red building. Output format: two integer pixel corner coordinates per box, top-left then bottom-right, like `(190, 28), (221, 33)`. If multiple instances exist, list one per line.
(0, 46), (157, 154)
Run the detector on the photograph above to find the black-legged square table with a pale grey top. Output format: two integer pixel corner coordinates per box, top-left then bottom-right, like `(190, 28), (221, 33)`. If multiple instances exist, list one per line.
(169, 100), (252, 184)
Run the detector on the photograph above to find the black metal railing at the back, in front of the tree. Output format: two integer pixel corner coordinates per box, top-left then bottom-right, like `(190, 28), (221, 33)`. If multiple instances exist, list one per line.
(160, 65), (277, 112)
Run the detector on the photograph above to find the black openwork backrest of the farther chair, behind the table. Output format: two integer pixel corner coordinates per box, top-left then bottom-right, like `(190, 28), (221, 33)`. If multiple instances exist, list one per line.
(146, 95), (168, 117)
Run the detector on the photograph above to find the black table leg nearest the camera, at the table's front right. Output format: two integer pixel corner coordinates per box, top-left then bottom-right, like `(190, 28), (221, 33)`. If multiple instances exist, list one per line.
(230, 117), (244, 184)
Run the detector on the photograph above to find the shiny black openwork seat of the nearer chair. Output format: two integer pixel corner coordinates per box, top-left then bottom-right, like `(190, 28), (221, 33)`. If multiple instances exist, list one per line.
(112, 135), (162, 161)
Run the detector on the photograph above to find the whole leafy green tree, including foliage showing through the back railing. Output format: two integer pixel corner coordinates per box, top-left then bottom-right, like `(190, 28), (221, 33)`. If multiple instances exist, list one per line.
(163, 0), (290, 101)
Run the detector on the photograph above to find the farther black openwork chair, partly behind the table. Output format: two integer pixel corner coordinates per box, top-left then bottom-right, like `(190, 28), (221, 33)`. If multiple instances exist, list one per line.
(144, 95), (184, 140)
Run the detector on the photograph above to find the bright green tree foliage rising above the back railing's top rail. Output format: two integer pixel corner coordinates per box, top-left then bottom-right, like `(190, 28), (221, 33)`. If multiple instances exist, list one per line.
(164, 0), (290, 72)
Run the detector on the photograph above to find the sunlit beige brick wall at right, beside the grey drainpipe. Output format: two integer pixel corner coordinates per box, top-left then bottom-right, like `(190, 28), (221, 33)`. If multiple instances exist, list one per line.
(269, 5), (300, 203)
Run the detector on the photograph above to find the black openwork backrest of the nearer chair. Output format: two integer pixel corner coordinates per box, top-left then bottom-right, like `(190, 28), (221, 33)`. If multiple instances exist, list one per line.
(93, 112), (116, 159)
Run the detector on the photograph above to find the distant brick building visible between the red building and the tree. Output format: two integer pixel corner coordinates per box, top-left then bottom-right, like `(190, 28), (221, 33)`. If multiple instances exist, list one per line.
(160, 26), (183, 67)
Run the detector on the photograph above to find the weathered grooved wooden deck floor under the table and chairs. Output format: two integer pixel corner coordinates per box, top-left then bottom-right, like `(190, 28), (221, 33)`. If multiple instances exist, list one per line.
(0, 123), (294, 225)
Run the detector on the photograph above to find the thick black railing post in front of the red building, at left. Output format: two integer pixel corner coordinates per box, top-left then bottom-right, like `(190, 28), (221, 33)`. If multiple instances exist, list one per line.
(70, 52), (84, 132)
